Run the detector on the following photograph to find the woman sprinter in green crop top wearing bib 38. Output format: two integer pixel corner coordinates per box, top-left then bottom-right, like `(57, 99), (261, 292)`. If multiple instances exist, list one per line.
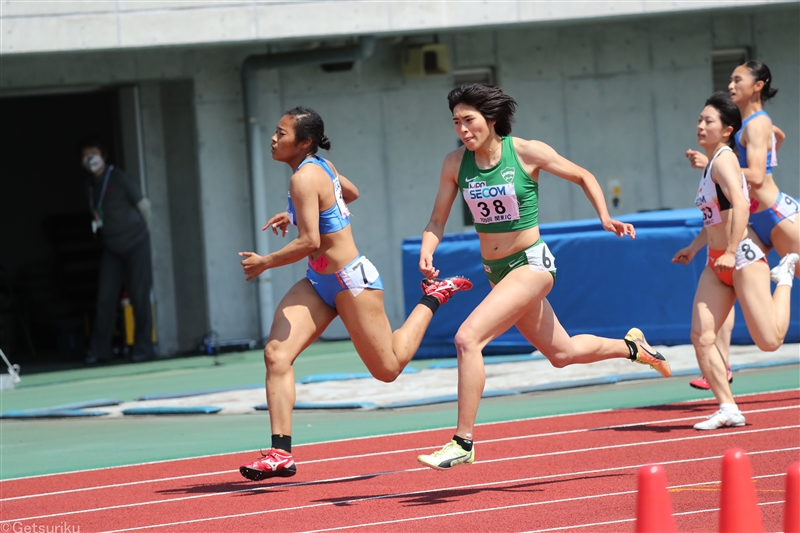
(418, 84), (670, 470)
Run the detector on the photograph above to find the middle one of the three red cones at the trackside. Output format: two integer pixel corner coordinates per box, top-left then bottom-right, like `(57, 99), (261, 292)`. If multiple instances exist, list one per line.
(719, 448), (764, 533)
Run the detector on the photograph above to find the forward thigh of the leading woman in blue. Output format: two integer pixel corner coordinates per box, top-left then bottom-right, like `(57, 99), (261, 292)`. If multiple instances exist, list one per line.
(269, 278), (336, 361)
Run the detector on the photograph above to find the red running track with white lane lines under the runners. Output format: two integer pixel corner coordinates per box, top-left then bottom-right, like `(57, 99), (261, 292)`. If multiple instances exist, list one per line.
(0, 390), (800, 533)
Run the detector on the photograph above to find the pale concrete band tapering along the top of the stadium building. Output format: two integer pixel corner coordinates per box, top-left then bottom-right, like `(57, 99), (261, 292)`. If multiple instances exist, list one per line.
(0, 0), (793, 53)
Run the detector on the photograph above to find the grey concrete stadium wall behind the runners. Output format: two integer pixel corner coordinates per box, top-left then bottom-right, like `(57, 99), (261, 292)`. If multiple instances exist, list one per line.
(0, 4), (800, 349)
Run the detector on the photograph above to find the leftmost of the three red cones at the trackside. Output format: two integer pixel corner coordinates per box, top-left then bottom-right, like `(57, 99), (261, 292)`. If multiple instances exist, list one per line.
(636, 465), (678, 533)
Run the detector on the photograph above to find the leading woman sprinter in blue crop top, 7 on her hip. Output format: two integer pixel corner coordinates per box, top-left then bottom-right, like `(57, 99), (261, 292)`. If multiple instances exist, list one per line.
(239, 107), (472, 481)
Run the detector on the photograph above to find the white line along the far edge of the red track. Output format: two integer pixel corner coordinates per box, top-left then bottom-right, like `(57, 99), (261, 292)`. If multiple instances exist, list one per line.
(0, 389), (800, 484)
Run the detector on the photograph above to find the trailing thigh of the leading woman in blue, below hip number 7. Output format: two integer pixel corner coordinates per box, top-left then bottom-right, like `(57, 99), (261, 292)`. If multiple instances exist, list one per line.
(336, 289), (394, 360)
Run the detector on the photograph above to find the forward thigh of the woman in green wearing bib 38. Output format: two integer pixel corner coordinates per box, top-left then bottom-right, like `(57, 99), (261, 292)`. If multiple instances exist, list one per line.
(460, 267), (553, 348)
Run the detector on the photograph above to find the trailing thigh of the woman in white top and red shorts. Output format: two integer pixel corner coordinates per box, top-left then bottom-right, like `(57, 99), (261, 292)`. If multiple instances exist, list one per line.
(733, 261), (775, 335)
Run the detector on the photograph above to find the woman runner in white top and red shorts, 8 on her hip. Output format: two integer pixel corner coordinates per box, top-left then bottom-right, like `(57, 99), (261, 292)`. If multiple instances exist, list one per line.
(673, 92), (800, 430)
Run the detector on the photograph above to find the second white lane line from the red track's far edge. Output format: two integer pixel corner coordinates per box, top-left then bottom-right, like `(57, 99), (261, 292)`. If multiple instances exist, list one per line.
(0, 405), (800, 501)
